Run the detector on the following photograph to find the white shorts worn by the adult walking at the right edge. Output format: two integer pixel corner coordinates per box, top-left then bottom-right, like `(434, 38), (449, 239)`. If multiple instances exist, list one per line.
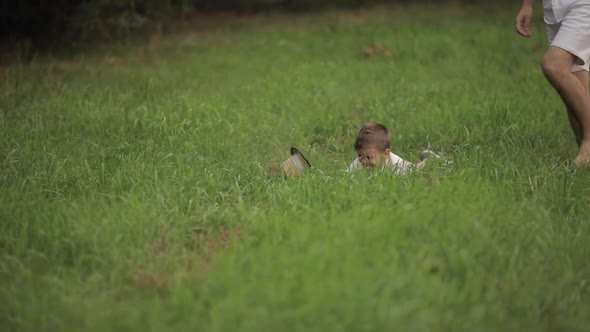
(546, 0), (590, 72)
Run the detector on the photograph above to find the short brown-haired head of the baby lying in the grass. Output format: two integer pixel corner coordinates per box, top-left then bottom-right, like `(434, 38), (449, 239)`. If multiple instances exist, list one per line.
(354, 122), (391, 167)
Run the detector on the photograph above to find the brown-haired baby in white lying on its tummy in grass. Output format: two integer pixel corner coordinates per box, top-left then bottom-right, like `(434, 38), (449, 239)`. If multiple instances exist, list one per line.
(348, 122), (433, 174)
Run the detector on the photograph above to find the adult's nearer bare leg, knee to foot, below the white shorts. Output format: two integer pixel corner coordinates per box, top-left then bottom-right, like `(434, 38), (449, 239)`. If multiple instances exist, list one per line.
(542, 46), (590, 164)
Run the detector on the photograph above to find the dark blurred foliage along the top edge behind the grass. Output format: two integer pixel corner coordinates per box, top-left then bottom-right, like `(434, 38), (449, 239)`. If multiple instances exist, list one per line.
(0, 0), (518, 49)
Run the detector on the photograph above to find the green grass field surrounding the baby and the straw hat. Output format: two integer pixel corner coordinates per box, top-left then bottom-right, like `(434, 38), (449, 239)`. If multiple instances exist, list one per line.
(0, 5), (590, 332)
